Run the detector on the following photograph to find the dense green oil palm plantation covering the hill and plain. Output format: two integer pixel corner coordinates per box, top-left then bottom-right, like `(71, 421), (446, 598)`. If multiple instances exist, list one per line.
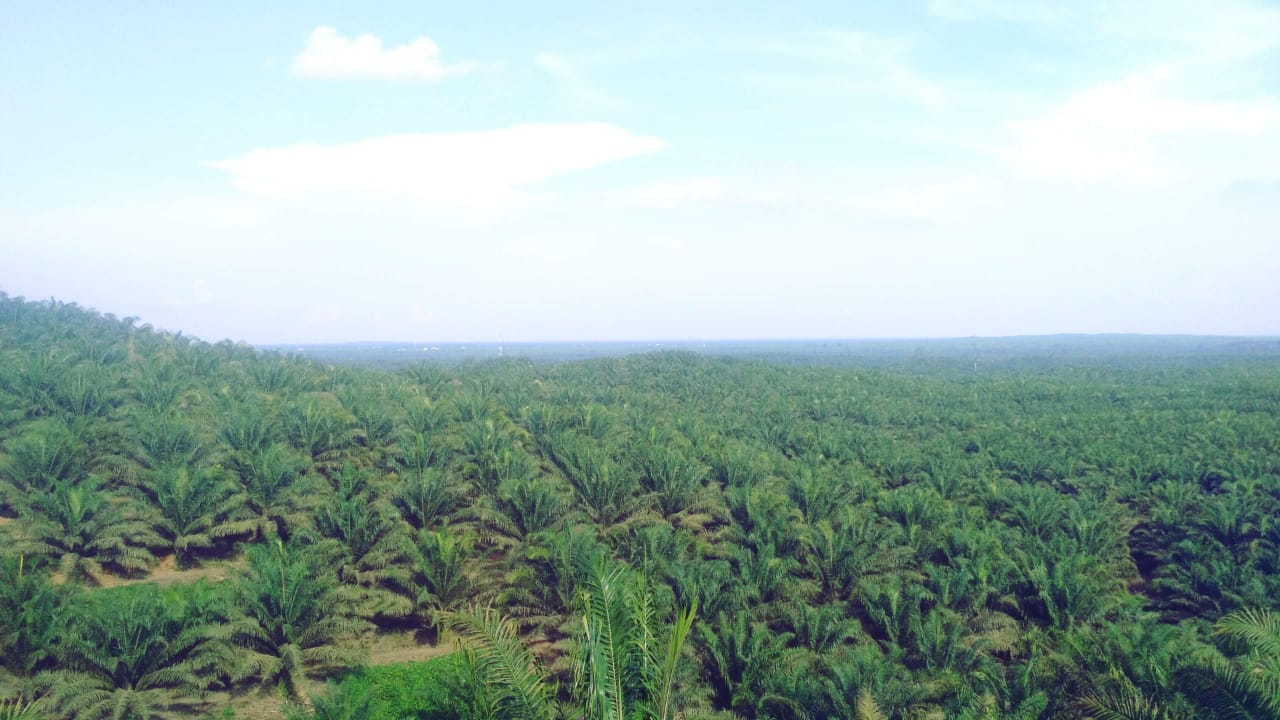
(0, 296), (1280, 720)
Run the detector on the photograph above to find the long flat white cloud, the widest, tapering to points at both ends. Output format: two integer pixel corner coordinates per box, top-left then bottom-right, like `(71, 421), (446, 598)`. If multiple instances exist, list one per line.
(210, 123), (663, 208)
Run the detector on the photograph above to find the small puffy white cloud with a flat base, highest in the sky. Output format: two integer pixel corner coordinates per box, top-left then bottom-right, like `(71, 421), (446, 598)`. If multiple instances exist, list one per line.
(292, 26), (475, 81)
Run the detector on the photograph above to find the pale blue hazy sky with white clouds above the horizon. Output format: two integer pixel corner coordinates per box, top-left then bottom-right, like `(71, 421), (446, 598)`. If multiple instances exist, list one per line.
(0, 0), (1280, 343)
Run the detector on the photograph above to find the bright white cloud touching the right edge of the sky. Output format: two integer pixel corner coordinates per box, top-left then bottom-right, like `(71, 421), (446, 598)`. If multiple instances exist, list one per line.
(1001, 70), (1280, 181)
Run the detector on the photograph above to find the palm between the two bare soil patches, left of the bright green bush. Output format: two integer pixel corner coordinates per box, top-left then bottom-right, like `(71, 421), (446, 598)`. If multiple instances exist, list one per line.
(234, 541), (371, 698)
